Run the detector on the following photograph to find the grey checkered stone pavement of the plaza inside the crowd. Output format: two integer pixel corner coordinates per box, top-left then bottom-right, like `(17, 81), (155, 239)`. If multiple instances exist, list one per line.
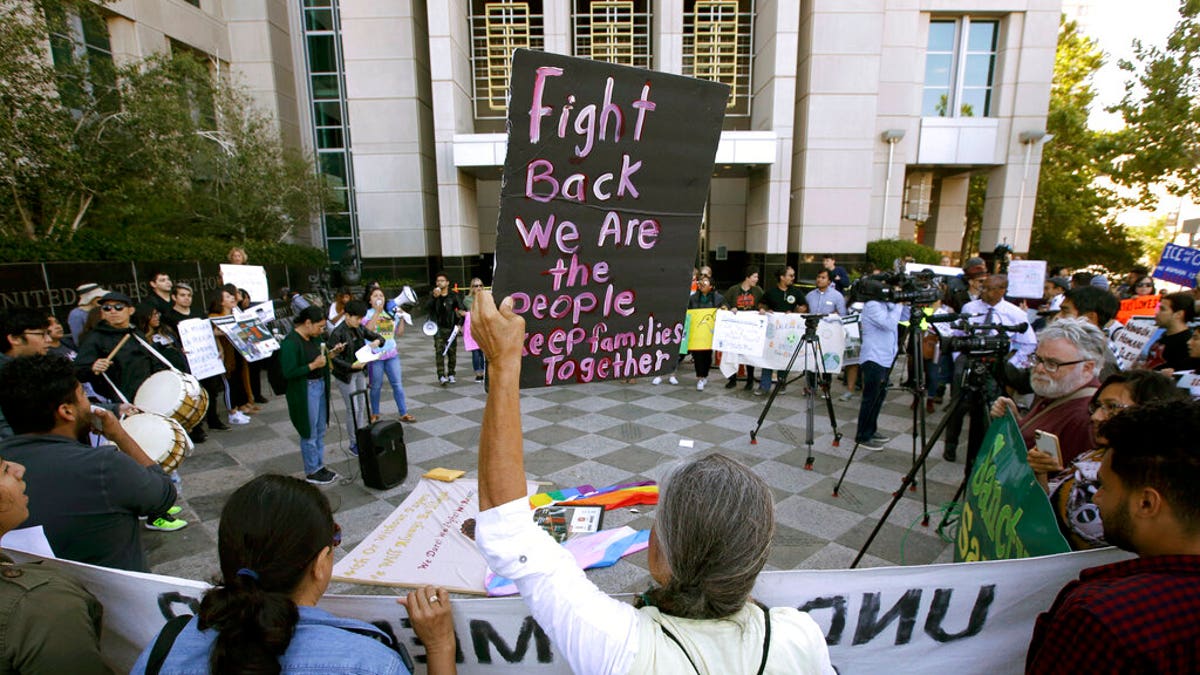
(143, 330), (962, 593)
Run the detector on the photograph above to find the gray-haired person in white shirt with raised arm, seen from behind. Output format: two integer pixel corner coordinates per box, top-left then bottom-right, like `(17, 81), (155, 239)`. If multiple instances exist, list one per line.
(470, 291), (834, 674)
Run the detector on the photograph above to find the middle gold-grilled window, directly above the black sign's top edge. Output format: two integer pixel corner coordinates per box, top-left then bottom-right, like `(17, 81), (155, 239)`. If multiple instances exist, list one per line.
(572, 0), (652, 68)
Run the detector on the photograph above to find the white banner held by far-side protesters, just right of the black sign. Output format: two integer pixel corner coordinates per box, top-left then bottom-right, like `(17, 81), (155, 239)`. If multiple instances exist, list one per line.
(714, 312), (846, 377)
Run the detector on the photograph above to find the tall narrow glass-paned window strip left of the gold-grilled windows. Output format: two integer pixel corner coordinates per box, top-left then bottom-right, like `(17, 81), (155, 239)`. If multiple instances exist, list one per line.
(301, 0), (359, 261)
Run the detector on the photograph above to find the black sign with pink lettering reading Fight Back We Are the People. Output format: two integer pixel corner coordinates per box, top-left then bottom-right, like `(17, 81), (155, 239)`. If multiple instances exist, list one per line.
(493, 49), (728, 387)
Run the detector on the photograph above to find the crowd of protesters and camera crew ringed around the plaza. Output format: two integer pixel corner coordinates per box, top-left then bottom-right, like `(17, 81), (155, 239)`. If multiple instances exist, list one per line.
(0, 250), (1200, 673)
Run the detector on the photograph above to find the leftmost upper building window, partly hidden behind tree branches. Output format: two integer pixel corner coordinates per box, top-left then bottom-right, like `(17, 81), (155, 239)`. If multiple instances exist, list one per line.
(46, 5), (120, 113)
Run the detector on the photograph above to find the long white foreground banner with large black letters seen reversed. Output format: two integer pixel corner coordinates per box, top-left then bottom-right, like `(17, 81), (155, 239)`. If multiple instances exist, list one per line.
(13, 549), (1130, 675)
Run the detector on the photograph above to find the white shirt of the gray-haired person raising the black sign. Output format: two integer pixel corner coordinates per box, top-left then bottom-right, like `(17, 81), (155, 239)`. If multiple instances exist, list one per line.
(475, 497), (834, 675)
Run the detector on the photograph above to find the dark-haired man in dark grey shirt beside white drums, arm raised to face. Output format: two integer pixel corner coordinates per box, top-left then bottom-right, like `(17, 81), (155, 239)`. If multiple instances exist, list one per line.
(0, 356), (176, 572)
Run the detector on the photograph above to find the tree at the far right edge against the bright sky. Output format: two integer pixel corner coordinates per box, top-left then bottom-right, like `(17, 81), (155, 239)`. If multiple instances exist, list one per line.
(1110, 0), (1200, 207)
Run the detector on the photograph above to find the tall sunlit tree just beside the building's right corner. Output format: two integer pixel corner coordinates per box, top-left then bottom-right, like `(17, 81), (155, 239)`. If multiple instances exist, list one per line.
(1030, 20), (1138, 269)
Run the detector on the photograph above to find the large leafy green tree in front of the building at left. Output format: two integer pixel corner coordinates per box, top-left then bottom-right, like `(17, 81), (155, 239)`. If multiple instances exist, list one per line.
(0, 0), (329, 249)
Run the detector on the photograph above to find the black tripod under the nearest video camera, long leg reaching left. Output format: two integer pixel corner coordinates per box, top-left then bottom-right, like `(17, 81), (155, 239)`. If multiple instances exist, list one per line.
(847, 343), (1004, 568)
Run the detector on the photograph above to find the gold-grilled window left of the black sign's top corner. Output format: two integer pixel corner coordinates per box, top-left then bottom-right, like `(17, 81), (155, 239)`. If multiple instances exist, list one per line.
(470, 0), (545, 120)
